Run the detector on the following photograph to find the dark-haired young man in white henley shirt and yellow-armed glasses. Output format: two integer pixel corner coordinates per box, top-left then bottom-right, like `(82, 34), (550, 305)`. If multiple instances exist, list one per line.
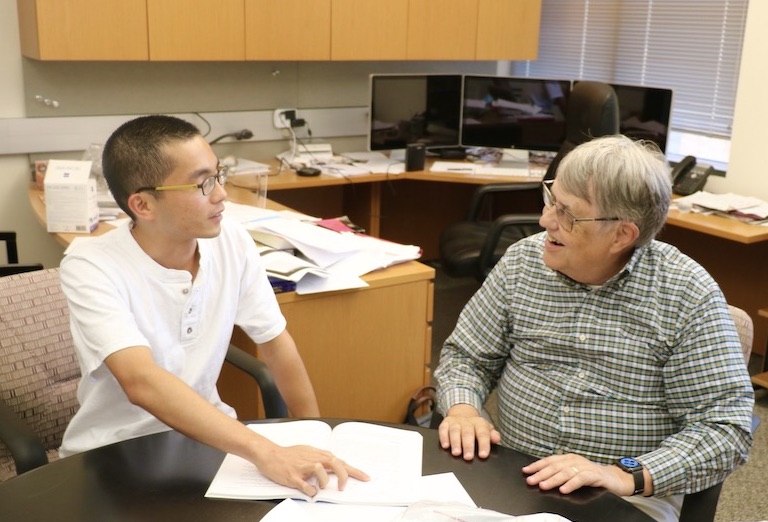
(60, 116), (367, 495)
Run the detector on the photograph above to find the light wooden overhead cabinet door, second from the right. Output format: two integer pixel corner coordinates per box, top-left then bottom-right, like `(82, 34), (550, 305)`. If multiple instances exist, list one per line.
(407, 0), (476, 60)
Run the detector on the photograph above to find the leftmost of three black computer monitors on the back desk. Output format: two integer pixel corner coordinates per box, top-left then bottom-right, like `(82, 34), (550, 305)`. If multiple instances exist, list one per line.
(368, 74), (461, 150)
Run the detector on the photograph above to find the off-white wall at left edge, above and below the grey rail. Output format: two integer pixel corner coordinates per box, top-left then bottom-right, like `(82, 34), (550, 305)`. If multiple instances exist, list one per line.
(0, 0), (63, 267)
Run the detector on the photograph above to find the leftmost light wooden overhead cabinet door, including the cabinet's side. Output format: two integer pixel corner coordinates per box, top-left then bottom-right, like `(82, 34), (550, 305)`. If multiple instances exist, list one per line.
(17, 0), (149, 60)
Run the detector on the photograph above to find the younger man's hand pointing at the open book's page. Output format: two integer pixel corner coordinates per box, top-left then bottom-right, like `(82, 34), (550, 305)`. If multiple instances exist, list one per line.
(256, 445), (369, 497)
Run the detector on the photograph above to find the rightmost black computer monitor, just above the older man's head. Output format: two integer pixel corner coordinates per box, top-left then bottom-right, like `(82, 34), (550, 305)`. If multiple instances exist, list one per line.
(611, 84), (672, 152)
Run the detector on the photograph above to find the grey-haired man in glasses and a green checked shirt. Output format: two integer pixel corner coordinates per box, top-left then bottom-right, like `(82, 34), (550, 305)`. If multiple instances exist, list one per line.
(435, 136), (754, 520)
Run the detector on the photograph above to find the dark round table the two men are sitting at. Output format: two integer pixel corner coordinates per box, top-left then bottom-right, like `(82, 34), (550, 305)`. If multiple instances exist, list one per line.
(0, 419), (651, 522)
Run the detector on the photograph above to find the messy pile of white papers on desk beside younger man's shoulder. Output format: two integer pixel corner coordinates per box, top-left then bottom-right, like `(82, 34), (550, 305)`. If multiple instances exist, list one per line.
(226, 202), (421, 294)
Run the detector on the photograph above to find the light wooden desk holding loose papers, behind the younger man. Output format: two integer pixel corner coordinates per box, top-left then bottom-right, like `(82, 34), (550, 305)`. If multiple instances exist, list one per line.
(29, 185), (435, 422)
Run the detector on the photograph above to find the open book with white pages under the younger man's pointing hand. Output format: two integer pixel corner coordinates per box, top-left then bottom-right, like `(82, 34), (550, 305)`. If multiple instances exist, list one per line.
(205, 420), (423, 506)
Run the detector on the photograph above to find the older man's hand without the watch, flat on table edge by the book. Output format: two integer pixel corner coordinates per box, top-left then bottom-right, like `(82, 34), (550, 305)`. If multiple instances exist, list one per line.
(438, 404), (501, 460)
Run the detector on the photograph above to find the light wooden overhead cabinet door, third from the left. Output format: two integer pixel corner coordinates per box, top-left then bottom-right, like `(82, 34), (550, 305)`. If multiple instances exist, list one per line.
(245, 0), (331, 60)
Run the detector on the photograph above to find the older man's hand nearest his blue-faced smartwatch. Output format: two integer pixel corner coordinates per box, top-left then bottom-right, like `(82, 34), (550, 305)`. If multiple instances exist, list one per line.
(523, 453), (634, 496)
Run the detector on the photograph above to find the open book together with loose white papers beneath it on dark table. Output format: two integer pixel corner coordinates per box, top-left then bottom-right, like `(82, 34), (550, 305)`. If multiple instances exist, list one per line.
(205, 420), (476, 522)
